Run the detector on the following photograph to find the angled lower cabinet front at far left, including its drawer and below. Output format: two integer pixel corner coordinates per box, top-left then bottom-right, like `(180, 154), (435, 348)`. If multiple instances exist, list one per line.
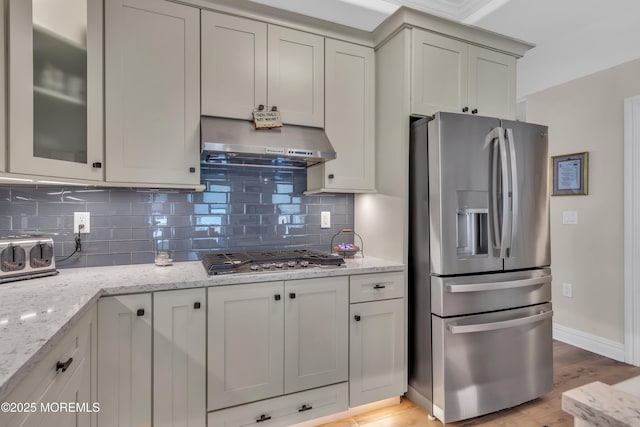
(0, 306), (97, 427)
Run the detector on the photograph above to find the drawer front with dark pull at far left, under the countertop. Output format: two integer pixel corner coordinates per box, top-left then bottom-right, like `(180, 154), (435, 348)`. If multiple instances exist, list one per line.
(0, 306), (96, 426)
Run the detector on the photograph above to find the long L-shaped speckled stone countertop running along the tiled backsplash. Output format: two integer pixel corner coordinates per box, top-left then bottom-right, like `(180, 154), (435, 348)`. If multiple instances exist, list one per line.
(0, 256), (405, 402)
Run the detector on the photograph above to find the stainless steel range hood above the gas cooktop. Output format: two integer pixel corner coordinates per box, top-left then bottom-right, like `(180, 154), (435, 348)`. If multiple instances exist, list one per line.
(200, 116), (336, 168)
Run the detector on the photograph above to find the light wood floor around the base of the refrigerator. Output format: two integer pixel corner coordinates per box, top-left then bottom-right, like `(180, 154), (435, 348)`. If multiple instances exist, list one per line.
(323, 341), (640, 427)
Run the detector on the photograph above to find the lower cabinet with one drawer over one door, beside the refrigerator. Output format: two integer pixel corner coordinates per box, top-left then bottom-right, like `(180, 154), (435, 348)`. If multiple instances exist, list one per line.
(349, 273), (406, 407)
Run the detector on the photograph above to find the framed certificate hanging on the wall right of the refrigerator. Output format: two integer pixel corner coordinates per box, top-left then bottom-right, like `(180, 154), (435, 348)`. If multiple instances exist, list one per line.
(551, 151), (589, 196)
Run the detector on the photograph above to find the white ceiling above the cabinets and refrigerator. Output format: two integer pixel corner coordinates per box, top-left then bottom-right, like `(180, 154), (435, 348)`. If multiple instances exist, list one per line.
(251, 0), (640, 98)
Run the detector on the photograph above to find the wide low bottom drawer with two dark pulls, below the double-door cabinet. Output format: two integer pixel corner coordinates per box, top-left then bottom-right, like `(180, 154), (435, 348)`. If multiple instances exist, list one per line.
(209, 382), (349, 427)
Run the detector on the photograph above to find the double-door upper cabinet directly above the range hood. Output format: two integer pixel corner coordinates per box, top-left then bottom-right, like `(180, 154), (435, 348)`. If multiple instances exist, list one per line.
(201, 11), (324, 127)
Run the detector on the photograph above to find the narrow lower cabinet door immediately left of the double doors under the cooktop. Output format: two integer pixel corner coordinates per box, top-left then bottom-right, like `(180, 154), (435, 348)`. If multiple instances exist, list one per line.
(153, 289), (207, 427)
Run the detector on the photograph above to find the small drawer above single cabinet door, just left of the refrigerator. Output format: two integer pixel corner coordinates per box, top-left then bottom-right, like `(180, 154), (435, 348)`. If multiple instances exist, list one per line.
(349, 272), (404, 303)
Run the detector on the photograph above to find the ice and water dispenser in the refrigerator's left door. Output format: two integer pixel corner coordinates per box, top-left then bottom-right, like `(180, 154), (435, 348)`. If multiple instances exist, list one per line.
(457, 191), (489, 257)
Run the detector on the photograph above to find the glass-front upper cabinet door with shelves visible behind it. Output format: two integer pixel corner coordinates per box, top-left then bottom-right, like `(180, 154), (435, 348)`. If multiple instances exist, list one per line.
(8, 0), (104, 181)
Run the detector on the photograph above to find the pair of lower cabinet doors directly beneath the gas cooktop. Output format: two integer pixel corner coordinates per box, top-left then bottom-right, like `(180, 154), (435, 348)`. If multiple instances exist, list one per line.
(208, 276), (348, 414)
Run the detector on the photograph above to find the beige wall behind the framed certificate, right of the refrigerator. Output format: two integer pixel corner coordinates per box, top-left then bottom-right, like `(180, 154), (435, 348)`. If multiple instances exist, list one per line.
(526, 56), (640, 343)
